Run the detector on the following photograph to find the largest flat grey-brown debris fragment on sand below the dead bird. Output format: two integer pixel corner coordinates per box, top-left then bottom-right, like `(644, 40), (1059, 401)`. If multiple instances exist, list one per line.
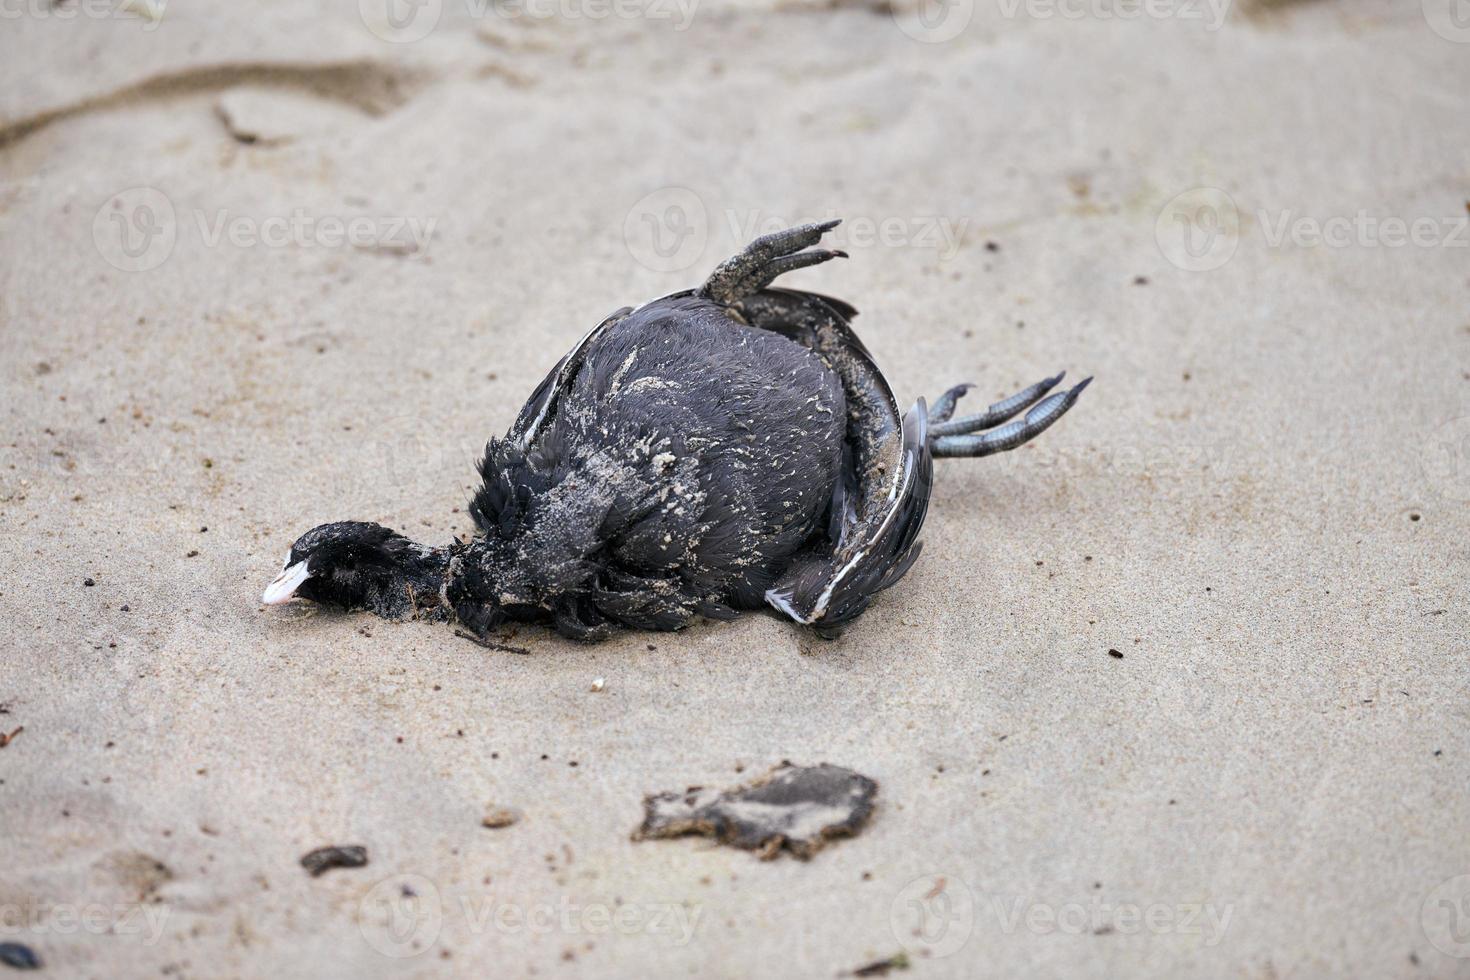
(634, 763), (878, 861)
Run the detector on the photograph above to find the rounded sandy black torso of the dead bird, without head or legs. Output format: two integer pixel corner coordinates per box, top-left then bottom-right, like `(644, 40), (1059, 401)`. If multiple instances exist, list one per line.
(470, 295), (847, 635)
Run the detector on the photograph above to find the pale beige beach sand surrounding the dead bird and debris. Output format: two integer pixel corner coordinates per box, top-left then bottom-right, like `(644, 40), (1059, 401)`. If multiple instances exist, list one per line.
(0, 0), (1470, 977)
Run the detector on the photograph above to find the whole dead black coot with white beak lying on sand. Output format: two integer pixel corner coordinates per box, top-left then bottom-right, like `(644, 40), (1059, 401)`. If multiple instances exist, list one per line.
(262, 220), (1091, 641)
